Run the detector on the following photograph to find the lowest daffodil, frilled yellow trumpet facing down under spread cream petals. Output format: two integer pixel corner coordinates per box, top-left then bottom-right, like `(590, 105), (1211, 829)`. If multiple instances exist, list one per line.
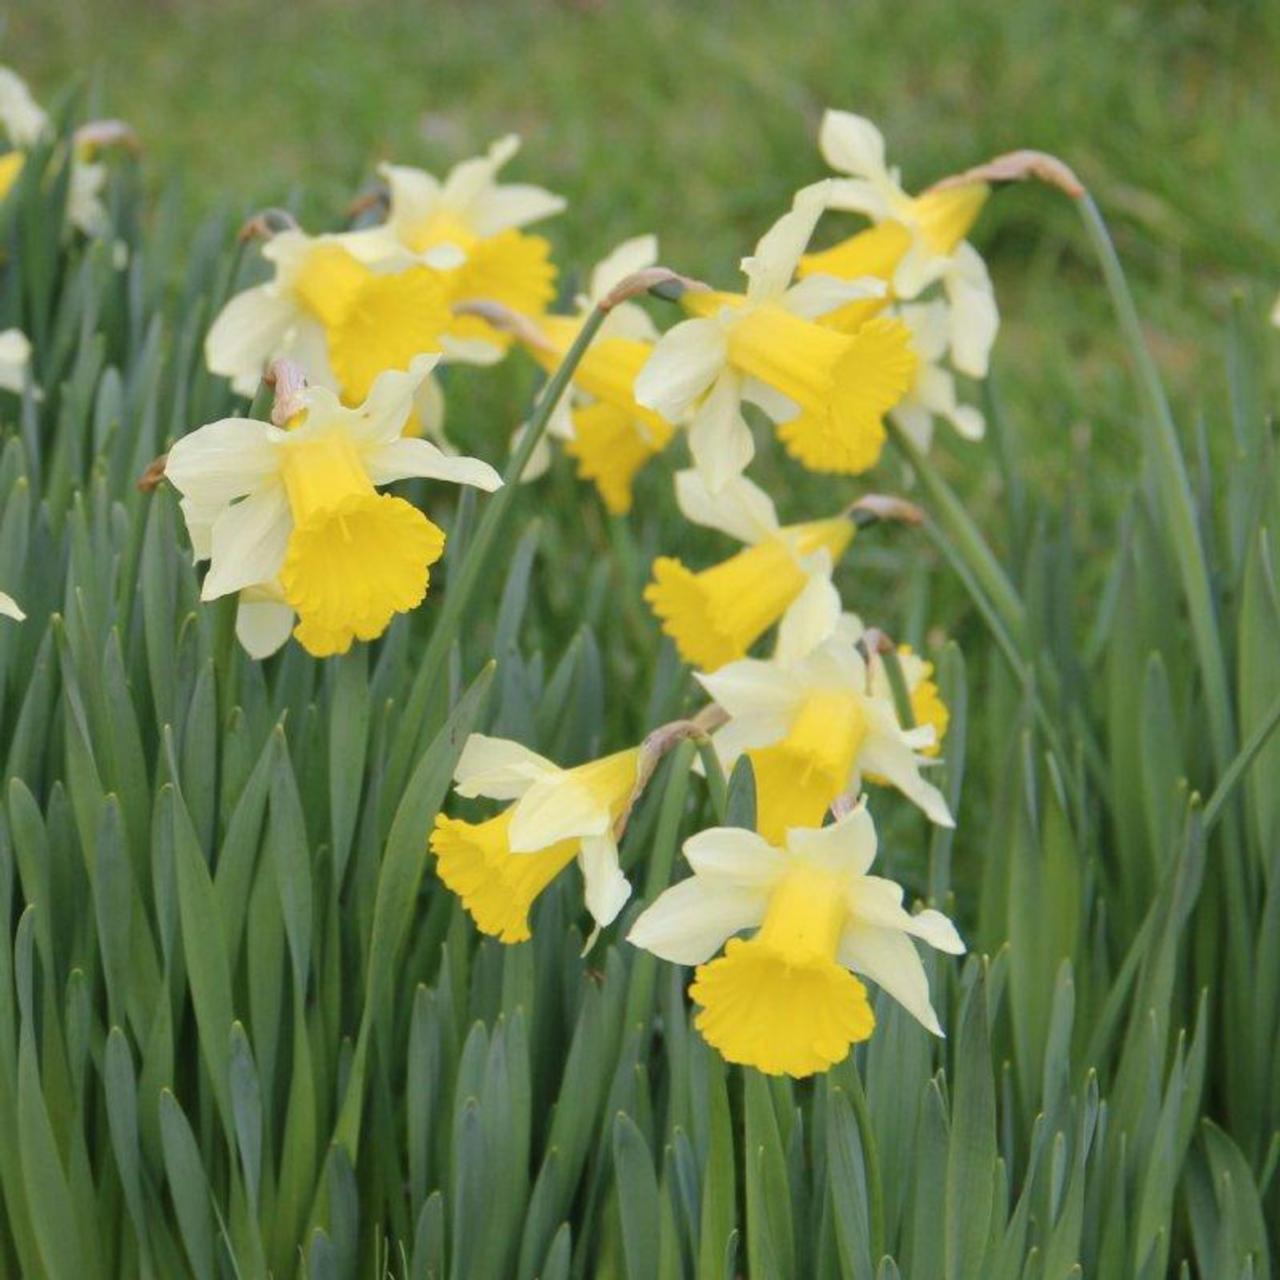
(628, 805), (965, 1076)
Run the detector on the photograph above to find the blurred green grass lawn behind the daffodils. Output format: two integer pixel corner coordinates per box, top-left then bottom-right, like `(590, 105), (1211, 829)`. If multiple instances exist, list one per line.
(10, 0), (1280, 514)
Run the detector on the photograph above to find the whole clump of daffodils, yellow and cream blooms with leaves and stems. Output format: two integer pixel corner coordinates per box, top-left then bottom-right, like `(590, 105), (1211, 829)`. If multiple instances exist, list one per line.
(0, 57), (1280, 1280)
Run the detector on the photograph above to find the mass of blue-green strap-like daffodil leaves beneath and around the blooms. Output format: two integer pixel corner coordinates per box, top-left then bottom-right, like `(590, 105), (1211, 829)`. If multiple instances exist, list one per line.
(0, 94), (1280, 1280)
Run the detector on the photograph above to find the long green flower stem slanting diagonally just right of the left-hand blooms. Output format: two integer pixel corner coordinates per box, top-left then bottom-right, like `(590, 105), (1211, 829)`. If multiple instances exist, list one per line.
(389, 307), (608, 795)
